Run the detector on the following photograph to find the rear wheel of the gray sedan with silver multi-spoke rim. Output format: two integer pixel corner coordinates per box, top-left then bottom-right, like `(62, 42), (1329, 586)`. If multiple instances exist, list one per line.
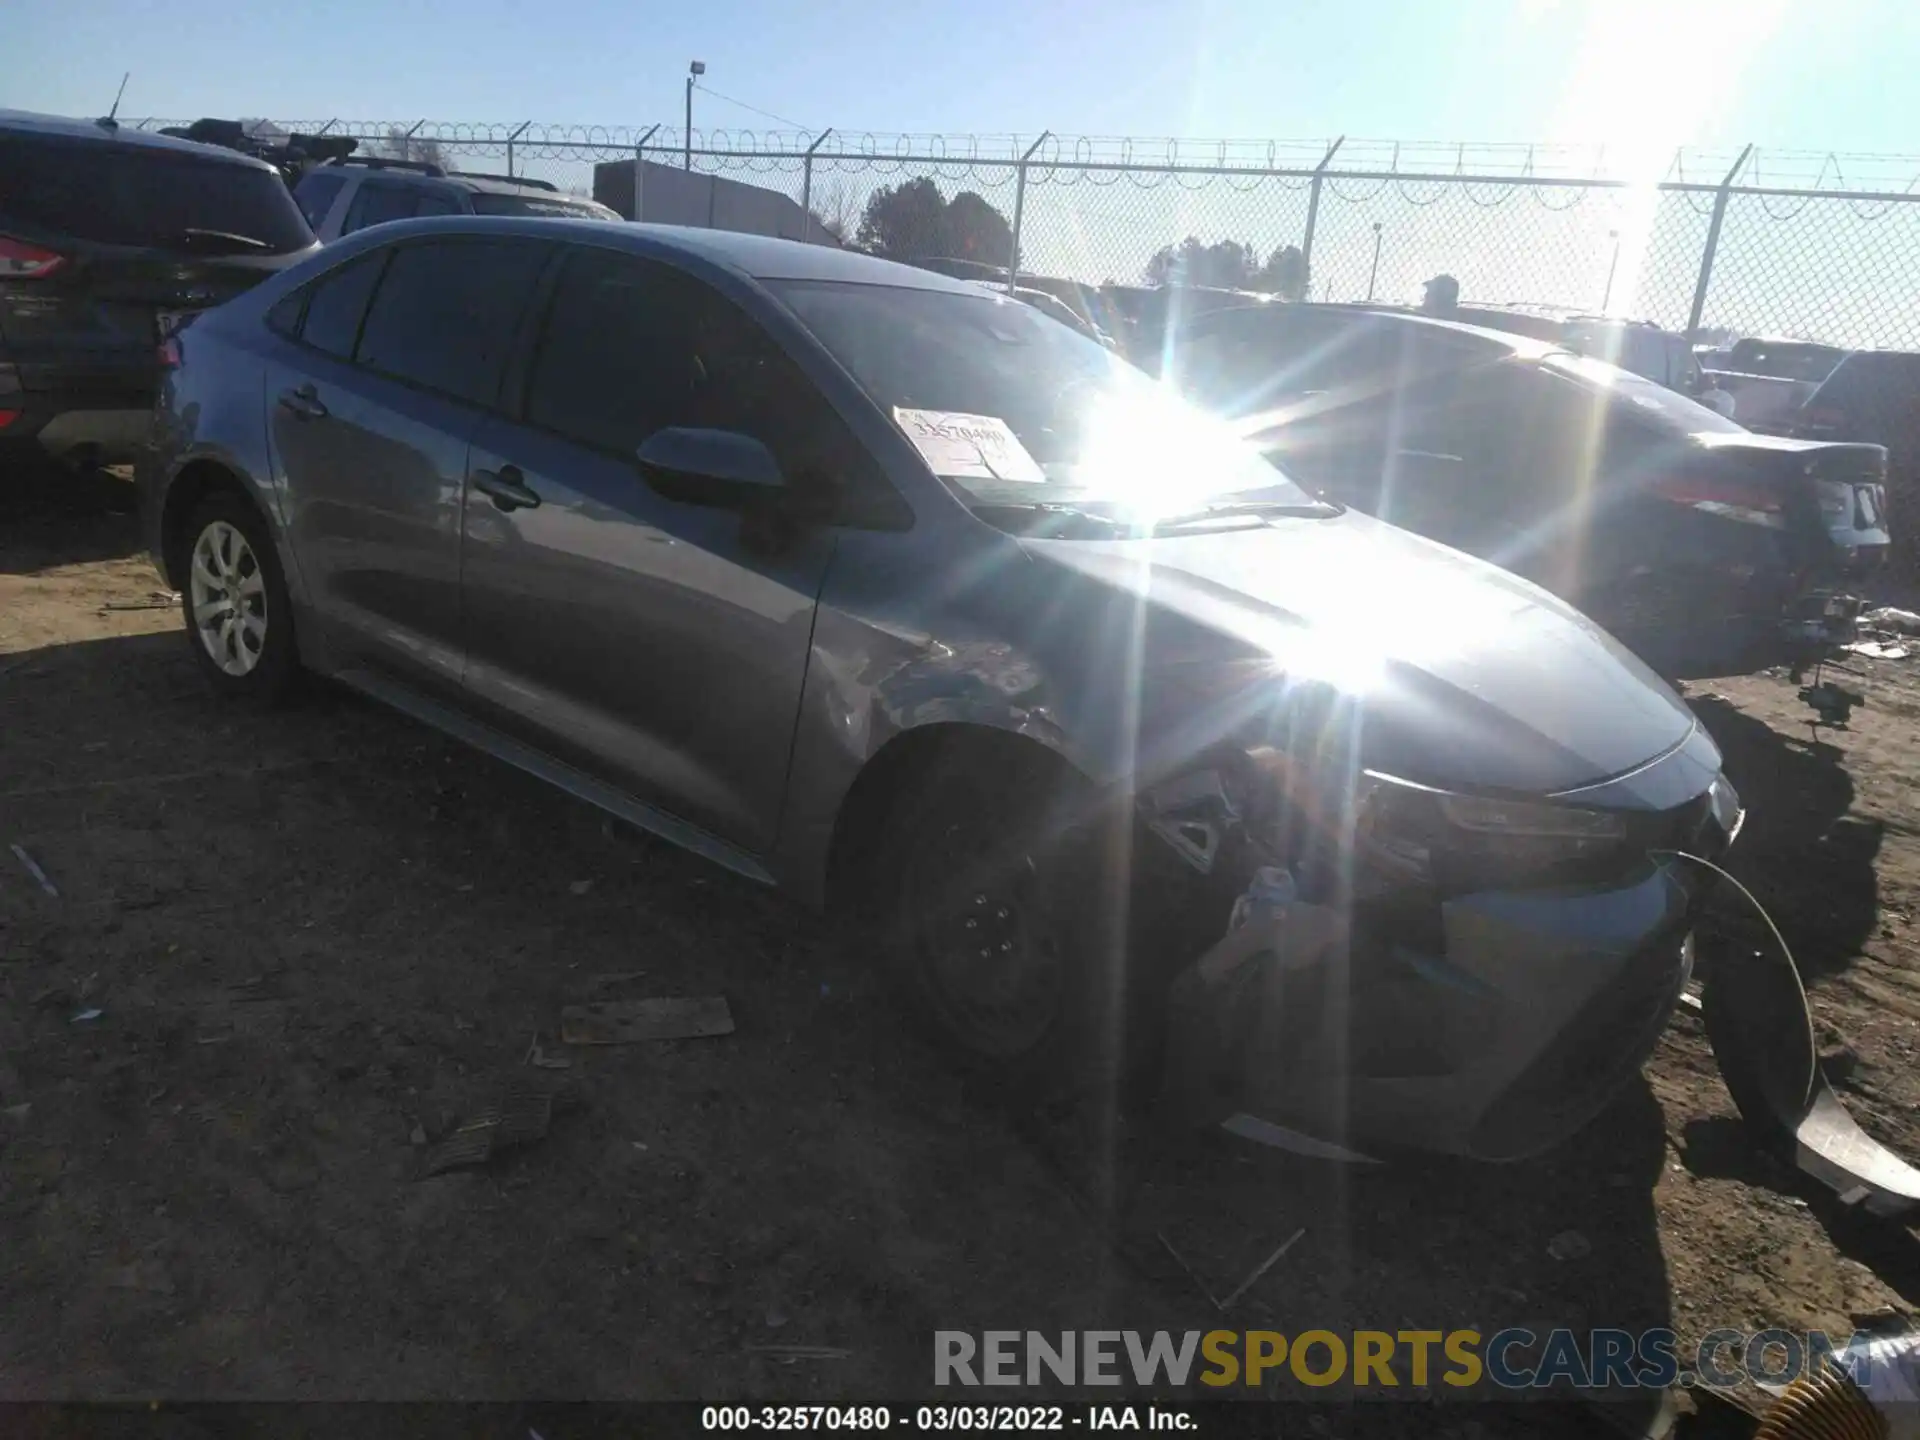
(180, 492), (300, 705)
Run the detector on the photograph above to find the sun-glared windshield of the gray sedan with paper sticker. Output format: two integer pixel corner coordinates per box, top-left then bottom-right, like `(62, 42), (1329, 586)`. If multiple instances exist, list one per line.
(774, 280), (1313, 520)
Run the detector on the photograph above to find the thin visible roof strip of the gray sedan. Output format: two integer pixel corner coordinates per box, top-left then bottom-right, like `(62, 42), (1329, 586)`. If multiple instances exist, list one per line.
(355, 215), (981, 298)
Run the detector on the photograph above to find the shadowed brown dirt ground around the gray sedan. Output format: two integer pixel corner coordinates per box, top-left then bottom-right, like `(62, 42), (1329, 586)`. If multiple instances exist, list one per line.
(0, 476), (1920, 1434)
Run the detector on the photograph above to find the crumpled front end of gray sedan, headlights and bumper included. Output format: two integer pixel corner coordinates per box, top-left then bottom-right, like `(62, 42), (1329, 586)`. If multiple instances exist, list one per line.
(1137, 732), (1740, 1160)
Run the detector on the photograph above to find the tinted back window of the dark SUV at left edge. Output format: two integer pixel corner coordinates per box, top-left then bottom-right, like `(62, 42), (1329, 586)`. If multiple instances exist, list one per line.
(0, 134), (313, 255)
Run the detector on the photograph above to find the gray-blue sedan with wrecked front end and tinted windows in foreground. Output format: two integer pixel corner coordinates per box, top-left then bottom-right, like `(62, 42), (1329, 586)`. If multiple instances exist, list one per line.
(142, 217), (1738, 1158)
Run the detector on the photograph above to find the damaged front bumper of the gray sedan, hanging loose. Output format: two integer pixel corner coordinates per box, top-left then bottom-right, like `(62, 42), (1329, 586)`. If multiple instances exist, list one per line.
(1164, 732), (1738, 1160)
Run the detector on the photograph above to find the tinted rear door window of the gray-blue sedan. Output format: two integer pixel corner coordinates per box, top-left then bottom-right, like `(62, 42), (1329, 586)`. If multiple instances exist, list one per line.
(355, 238), (547, 405)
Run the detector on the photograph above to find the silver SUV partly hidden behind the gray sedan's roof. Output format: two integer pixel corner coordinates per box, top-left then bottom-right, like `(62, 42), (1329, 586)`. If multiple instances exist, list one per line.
(294, 156), (620, 240)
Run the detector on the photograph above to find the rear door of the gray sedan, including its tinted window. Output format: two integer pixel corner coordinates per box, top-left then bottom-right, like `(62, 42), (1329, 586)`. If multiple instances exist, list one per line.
(267, 236), (553, 691)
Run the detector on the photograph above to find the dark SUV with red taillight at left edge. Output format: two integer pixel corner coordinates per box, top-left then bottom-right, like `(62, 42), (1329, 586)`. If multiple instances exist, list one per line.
(0, 111), (315, 474)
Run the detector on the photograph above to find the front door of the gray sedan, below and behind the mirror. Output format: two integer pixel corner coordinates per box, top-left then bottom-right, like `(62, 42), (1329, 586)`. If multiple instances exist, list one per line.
(463, 248), (864, 852)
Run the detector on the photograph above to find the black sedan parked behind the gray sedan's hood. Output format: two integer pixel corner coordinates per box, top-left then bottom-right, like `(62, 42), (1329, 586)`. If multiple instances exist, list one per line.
(1175, 305), (1889, 668)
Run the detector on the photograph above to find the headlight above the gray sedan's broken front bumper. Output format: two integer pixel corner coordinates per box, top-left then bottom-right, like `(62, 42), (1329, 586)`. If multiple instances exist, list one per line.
(1352, 772), (1628, 897)
